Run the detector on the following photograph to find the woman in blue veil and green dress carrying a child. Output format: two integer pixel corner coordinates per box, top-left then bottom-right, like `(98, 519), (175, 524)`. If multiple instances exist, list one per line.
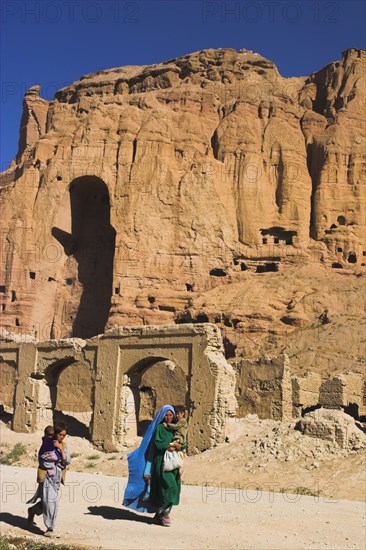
(123, 405), (181, 527)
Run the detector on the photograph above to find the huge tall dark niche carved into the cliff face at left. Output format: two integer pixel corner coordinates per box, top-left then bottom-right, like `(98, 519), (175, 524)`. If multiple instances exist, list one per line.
(52, 176), (116, 338)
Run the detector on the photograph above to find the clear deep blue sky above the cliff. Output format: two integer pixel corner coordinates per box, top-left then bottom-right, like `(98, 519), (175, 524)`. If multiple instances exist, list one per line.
(0, 0), (366, 169)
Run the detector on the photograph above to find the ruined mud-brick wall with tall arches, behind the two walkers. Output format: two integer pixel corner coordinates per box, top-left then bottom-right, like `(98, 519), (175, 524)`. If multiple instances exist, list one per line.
(0, 324), (236, 453)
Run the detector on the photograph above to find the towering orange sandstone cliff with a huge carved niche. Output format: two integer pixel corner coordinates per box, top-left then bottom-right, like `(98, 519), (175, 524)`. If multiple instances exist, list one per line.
(0, 49), (366, 364)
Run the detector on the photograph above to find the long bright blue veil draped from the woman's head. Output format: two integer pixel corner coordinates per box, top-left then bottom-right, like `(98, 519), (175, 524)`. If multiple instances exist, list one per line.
(123, 405), (175, 512)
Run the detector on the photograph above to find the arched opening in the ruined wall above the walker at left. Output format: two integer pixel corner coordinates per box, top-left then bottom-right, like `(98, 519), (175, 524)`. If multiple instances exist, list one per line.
(44, 358), (94, 439)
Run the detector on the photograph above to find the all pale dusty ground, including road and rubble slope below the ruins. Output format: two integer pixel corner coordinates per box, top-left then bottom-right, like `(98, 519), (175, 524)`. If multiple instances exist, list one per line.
(1, 416), (366, 550)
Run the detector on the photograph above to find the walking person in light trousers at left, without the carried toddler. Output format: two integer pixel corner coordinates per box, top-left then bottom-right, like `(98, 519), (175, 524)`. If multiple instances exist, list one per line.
(28, 422), (70, 538)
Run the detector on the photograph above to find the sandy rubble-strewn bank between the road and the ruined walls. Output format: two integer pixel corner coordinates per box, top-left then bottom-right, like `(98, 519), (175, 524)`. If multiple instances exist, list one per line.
(0, 415), (366, 501)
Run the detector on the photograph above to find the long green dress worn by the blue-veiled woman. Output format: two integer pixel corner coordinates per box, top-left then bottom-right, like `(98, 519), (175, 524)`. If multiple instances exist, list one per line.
(150, 424), (181, 511)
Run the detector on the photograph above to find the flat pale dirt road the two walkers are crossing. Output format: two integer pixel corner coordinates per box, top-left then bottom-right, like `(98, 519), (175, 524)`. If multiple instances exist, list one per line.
(0, 466), (365, 550)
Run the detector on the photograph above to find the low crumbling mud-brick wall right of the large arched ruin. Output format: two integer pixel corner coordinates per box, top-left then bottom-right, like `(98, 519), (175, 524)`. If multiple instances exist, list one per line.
(231, 354), (366, 420)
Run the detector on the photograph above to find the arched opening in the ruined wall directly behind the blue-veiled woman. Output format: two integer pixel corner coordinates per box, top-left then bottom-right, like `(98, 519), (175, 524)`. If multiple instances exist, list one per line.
(124, 357), (189, 436)
